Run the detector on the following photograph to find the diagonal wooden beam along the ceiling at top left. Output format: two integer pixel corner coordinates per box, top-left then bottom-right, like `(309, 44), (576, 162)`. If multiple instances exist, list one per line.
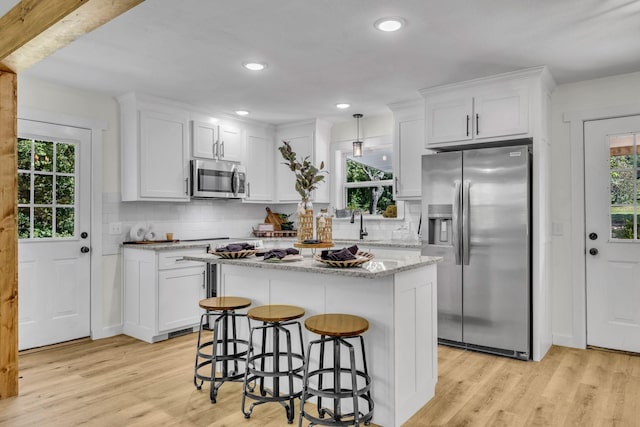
(0, 0), (144, 73)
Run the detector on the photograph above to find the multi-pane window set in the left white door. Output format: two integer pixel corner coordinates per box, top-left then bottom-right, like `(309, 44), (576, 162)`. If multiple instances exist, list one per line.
(18, 138), (76, 239)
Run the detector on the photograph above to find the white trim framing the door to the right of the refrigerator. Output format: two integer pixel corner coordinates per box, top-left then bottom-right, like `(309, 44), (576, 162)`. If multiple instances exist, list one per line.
(564, 104), (640, 348)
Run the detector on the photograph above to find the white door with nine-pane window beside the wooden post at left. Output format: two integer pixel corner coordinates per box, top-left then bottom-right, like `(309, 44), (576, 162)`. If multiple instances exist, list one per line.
(18, 120), (91, 350)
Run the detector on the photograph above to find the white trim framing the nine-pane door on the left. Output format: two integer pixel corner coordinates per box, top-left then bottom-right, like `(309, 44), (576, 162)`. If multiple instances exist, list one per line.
(18, 106), (110, 340)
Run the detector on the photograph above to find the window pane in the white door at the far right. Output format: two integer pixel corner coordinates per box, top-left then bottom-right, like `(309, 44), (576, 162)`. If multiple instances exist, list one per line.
(608, 133), (640, 241)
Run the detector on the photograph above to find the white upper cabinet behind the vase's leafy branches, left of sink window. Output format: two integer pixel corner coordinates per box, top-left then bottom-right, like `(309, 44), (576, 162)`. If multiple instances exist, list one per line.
(274, 119), (331, 203)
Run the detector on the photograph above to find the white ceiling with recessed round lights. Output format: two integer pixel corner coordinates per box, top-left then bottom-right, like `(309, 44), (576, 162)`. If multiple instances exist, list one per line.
(0, 0), (640, 123)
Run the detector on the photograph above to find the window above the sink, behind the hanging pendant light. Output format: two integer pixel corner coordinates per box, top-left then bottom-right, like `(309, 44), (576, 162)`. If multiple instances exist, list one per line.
(334, 136), (403, 219)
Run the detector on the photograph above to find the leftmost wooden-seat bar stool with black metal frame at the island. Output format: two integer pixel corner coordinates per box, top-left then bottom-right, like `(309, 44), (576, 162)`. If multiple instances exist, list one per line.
(193, 296), (251, 403)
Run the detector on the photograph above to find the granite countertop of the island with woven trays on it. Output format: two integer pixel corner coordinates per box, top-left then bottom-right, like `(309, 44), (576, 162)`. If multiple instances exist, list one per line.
(183, 254), (442, 279)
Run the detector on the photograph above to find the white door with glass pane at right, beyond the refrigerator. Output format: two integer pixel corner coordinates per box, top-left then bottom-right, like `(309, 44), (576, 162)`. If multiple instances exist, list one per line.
(584, 116), (640, 353)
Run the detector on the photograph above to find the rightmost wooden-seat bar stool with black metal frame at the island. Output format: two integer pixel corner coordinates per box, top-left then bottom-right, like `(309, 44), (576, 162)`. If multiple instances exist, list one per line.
(298, 314), (373, 426)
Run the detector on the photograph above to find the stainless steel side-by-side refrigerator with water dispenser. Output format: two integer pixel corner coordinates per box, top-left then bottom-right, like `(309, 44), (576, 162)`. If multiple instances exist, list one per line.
(422, 146), (531, 359)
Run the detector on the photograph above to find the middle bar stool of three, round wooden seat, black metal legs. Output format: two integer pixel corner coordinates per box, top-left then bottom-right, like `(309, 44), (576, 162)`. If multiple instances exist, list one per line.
(242, 305), (304, 424)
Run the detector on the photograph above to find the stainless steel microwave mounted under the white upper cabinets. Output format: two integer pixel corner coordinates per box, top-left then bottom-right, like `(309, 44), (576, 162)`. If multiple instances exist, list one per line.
(191, 160), (247, 199)
